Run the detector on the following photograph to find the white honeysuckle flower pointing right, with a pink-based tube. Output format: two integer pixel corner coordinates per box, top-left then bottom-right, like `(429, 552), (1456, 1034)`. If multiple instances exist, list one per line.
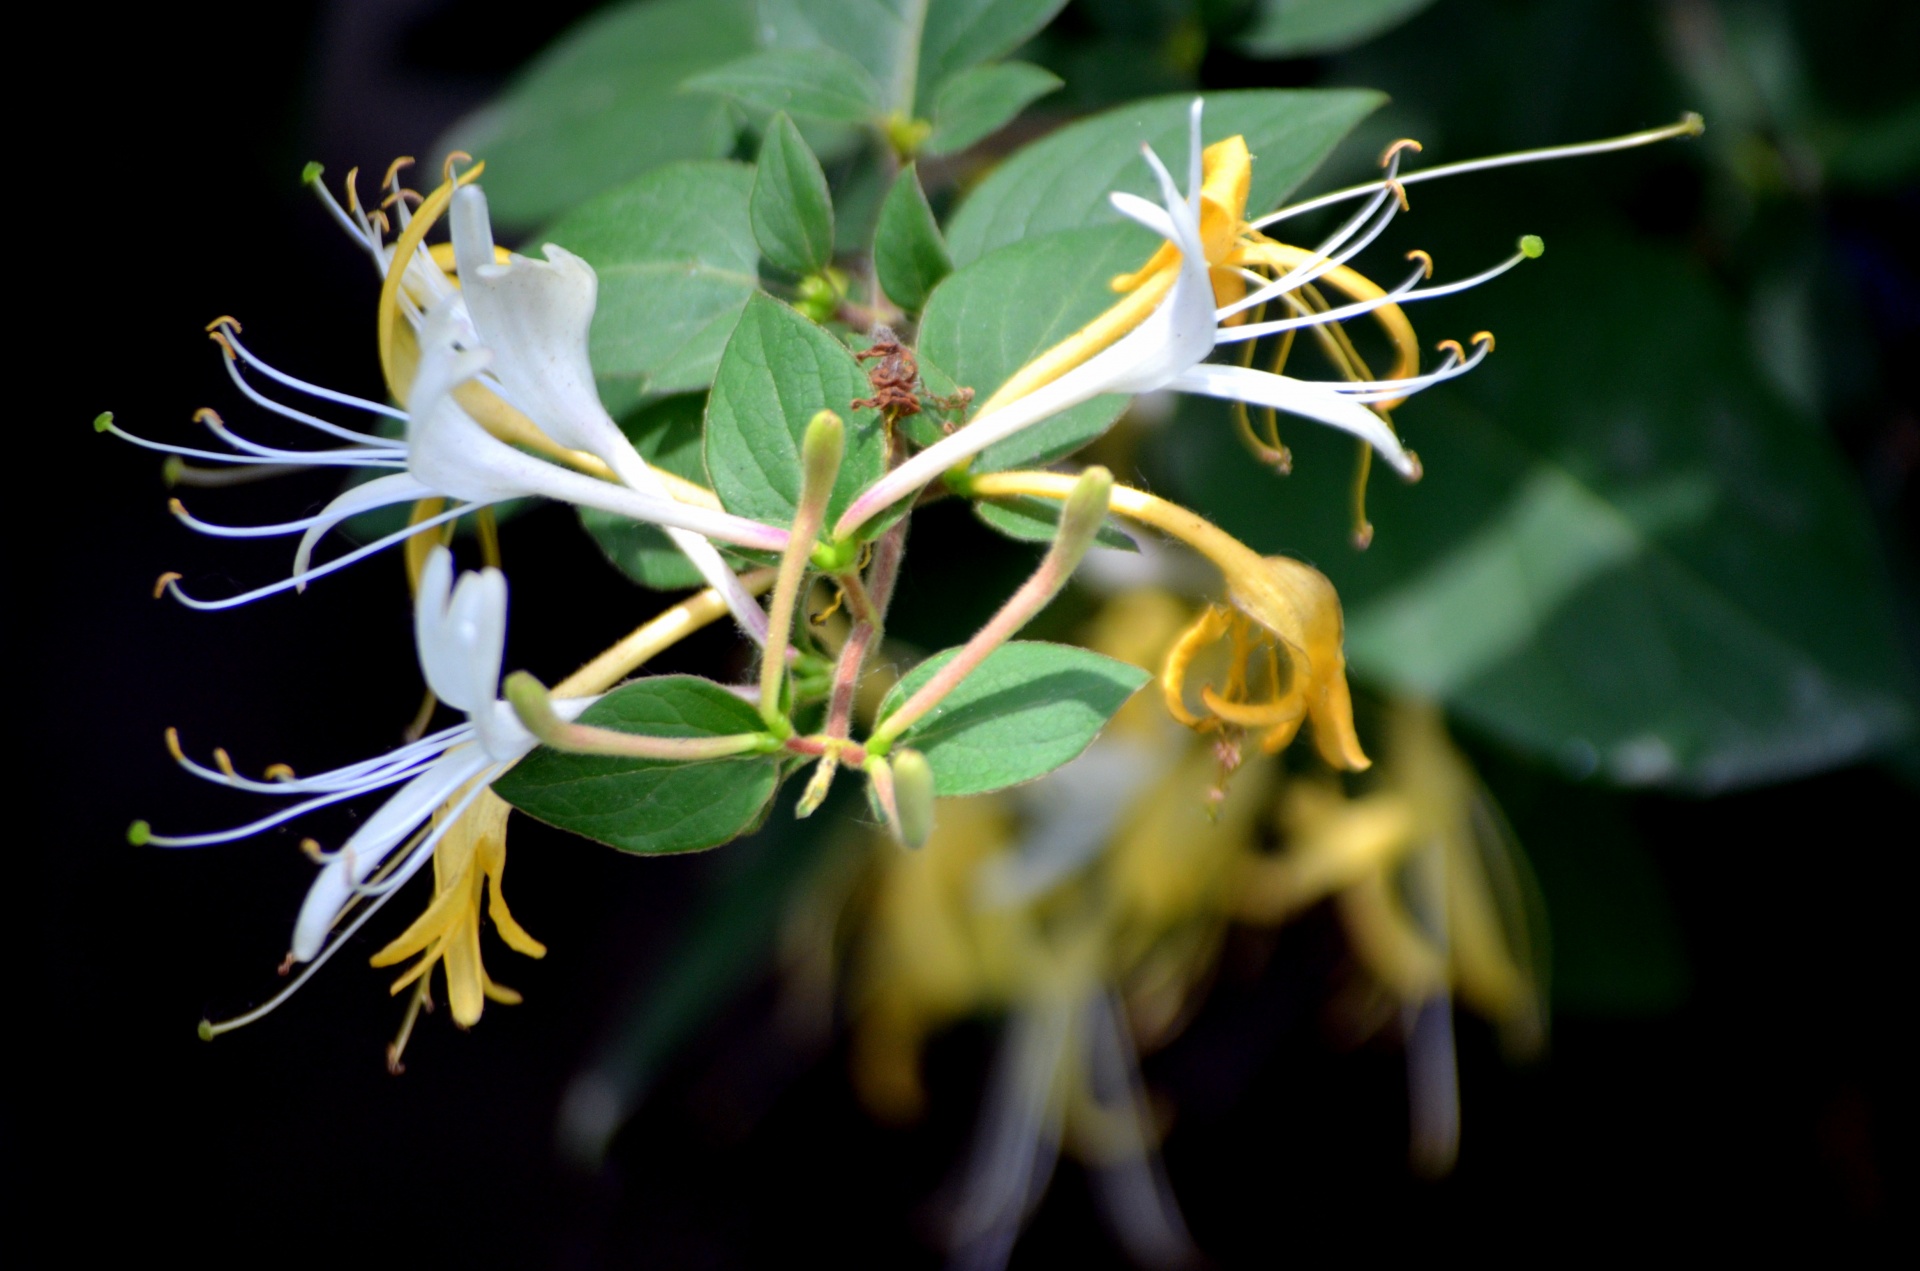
(835, 100), (1540, 538)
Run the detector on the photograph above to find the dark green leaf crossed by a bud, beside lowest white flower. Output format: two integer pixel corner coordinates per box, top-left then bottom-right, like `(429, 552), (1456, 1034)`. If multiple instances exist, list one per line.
(493, 676), (780, 856)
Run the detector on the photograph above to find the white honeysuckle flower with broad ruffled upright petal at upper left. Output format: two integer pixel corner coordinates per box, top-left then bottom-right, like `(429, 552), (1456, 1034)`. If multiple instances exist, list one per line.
(447, 186), (766, 643)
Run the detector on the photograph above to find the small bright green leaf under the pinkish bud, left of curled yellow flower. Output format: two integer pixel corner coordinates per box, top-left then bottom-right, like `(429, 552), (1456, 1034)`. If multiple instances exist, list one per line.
(879, 639), (1152, 795)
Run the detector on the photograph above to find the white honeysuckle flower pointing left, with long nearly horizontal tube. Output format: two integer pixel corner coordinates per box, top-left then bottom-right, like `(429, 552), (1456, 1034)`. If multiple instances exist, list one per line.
(108, 303), (787, 626)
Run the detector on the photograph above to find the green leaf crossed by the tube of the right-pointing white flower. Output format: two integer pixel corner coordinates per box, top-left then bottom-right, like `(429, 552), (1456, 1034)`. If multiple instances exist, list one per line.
(920, 223), (1156, 472)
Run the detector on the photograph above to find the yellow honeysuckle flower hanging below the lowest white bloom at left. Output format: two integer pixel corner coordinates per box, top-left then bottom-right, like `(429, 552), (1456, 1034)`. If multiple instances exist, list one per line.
(371, 791), (547, 1029)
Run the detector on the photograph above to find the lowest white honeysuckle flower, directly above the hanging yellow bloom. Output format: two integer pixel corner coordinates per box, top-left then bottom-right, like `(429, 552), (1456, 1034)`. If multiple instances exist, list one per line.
(131, 547), (597, 1029)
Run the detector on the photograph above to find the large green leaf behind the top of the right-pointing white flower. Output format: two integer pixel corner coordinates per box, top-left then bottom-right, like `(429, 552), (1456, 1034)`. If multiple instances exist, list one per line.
(947, 88), (1386, 265)
